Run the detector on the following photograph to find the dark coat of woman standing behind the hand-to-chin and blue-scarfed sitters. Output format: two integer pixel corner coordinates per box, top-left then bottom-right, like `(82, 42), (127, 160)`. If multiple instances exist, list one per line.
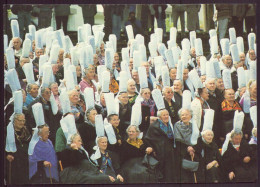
(78, 123), (97, 155)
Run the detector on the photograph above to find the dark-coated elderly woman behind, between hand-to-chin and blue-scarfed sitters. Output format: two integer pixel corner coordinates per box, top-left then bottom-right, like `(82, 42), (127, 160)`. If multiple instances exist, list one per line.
(78, 108), (97, 155)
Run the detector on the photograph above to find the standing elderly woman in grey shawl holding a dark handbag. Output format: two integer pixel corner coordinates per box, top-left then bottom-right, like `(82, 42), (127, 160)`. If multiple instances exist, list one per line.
(173, 109), (198, 183)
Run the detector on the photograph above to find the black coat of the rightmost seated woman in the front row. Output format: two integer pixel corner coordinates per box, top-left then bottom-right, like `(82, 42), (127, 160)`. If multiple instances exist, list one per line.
(222, 140), (257, 182)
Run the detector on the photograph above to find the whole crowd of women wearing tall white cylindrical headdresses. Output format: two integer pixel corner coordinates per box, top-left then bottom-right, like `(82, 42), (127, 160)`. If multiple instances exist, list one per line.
(4, 3), (258, 184)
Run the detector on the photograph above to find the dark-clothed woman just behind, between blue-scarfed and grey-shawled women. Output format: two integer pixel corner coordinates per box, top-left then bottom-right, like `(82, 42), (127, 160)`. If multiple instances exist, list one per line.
(163, 86), (179, 124)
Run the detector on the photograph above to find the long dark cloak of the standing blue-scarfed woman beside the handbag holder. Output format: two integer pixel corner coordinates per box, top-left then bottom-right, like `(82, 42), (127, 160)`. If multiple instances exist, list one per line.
(144, 121), (177, 182)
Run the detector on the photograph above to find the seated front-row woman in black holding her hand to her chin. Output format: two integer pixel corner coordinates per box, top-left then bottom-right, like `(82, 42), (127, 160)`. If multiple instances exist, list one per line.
(60, 134), (113, 184)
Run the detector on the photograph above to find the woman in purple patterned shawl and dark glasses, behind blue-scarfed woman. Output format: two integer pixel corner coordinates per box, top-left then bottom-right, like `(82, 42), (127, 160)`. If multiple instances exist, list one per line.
(140, 88), (158, 136)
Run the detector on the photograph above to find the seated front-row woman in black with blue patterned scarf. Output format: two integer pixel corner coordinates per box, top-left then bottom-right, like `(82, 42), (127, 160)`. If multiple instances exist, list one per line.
(92, 136), (124, 183)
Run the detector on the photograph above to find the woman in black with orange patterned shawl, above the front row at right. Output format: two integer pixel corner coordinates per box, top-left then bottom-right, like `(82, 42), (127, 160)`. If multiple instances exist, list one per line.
(220, 89), (242, 138)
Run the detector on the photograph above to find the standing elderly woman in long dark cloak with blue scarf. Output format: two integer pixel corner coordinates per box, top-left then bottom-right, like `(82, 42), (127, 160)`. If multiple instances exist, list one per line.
(144, 109), (178, 182)
